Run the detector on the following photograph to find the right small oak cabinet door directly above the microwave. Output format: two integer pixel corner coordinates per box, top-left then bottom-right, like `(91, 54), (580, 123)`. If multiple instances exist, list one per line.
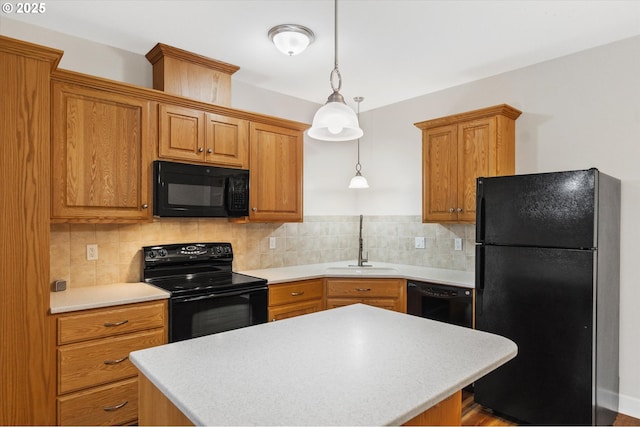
(205, 113), (249, 169)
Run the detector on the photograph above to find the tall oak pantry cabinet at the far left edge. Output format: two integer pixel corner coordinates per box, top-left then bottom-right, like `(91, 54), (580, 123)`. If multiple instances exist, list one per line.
(0, 36), (62, 425)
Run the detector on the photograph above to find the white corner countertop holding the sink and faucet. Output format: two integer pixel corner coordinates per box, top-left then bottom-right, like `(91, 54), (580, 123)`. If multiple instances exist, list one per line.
(239, 261), (475, 288)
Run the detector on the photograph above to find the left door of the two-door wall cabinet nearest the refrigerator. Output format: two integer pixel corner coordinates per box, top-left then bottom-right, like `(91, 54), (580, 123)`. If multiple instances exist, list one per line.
(422, 125), (458, 222)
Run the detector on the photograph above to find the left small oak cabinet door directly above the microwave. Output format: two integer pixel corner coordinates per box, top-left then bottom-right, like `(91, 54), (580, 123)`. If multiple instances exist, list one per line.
(158, 104), (205, 162)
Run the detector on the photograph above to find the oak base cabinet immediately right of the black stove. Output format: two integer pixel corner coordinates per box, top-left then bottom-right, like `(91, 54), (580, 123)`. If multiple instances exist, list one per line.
(269, 279), (325, 321)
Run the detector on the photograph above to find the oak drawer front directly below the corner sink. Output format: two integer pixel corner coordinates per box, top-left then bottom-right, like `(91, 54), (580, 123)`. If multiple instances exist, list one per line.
(327, 279), (404, 298)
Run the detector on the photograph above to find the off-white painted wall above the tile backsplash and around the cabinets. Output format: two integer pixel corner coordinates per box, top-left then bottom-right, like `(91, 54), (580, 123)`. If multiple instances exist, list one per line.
(5, 17), (640, 418)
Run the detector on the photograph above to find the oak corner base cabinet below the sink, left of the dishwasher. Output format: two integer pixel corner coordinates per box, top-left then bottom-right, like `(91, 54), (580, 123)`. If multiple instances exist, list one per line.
(326, 278), (407, 313)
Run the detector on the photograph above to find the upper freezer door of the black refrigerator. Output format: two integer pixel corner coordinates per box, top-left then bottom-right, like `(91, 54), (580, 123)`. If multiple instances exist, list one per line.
(476, 169), (598, 248)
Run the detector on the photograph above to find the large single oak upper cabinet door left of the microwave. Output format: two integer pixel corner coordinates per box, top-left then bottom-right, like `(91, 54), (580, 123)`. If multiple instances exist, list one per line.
(51, 82), (152, 222)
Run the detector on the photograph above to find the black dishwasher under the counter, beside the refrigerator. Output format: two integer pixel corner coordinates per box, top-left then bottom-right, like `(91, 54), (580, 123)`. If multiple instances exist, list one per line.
(407, 280), (473, 328)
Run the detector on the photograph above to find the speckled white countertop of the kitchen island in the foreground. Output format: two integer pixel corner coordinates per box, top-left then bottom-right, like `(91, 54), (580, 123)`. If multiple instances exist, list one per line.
(130, 304), (517, 425)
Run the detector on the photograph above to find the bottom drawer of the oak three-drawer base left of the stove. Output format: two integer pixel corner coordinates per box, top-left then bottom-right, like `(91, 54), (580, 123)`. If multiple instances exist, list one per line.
(58, 377), (138, 426)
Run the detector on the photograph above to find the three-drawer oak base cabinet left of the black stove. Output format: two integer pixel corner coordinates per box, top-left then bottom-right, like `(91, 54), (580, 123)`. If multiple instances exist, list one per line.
(54, 301), (167, 425)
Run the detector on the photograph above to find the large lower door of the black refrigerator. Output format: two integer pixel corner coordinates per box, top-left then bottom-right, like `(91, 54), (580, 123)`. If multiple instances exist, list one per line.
(475, 246), (594, 425)
